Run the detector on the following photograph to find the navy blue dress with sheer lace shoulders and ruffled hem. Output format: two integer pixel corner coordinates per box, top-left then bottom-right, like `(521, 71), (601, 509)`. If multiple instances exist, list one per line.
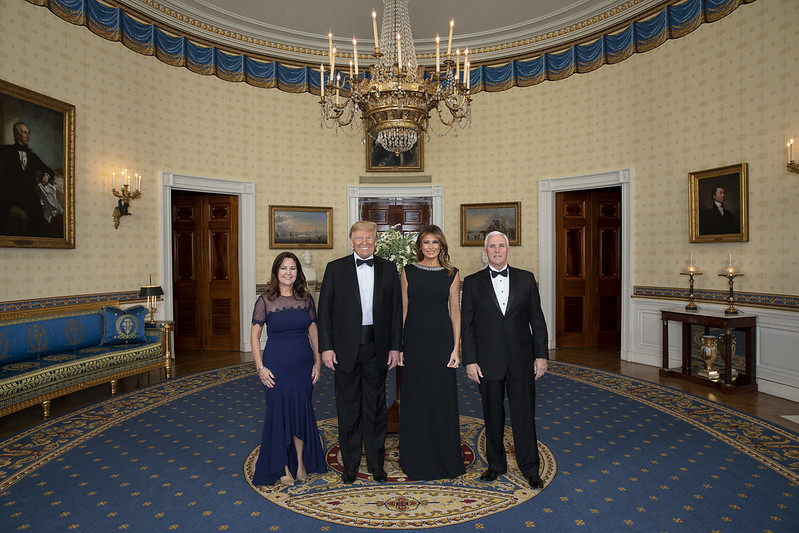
(252, 295), (327, 485)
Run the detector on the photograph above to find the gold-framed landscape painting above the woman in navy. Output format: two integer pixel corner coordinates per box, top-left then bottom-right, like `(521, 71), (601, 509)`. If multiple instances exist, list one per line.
(269, 205), (333, 248)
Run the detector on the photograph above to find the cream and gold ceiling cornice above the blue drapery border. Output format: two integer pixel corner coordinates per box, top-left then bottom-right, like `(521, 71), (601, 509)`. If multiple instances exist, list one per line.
(120, 0), (668, 65)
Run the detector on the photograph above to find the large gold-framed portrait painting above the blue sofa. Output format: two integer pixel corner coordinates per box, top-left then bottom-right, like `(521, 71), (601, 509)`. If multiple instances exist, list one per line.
(0, 80), (75, 248)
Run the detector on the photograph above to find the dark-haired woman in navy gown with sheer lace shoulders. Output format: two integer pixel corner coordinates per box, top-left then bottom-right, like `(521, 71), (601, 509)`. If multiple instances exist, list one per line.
(250, 252), (327, 486)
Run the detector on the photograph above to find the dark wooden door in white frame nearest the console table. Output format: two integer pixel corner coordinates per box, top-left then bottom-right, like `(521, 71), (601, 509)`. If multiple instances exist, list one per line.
(555, 188), (621, 348)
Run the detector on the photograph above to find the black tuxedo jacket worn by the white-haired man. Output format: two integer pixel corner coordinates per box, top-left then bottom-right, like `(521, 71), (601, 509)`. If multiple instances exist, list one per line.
(461, 267), (549, 379)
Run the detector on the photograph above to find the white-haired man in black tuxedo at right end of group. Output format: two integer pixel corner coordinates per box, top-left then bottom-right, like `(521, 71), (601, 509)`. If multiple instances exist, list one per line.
(461, 231), (549, 489)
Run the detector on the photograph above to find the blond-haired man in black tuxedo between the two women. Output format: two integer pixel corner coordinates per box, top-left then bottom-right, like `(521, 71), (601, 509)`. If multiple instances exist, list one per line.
(317, 221), (402, 483)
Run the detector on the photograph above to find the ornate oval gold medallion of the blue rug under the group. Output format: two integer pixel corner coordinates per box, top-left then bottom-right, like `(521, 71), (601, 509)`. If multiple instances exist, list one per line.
(244, 416), (557, 529)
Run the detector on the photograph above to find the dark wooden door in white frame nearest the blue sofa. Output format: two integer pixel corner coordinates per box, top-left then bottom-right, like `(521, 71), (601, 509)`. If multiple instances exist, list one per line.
(172, 191), (240, 350)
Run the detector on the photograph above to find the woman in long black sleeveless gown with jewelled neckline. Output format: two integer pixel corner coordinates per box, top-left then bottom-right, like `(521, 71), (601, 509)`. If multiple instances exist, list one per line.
(400, 225), (465, 480)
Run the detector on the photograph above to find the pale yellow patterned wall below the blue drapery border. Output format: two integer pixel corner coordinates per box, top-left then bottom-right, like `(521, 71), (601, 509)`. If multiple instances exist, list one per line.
(0, 0), (799, 301)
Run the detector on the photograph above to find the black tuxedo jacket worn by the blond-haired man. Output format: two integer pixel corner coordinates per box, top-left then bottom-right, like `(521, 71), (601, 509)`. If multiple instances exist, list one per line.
(317, 255), (402, 372)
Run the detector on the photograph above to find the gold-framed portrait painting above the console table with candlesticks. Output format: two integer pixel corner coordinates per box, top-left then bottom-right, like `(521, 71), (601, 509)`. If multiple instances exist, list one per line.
(688, 163), (749, 242)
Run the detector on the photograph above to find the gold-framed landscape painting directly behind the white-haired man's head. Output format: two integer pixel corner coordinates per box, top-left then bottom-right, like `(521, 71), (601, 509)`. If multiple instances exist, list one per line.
(461, 202), (522, 246)
